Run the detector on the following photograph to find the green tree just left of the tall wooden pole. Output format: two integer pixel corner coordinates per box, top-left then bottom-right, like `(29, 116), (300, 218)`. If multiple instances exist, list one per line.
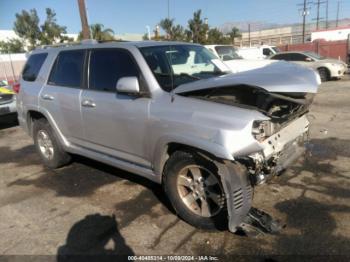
(40, 8), (69, 45)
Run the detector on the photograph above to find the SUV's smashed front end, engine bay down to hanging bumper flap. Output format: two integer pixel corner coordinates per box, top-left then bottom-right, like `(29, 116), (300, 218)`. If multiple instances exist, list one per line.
(181, 85), (314, 232)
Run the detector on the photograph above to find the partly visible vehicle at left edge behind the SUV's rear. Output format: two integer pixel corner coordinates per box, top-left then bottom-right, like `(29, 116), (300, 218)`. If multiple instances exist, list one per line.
(0, 81), (17, 116)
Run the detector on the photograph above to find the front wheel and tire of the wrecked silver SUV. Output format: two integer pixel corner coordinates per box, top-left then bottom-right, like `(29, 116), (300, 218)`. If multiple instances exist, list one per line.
(163, 151), (227, 229)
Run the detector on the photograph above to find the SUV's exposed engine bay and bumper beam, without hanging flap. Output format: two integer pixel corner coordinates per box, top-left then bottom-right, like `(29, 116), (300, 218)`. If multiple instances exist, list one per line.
(182, 85), (314, 185)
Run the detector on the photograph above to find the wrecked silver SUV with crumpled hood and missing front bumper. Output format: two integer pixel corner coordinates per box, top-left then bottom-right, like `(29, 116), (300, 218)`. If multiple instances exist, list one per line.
(17, 41), (320, 231)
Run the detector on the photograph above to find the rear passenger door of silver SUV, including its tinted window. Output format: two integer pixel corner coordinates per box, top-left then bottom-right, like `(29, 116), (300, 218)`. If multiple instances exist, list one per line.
(39, 50), (86, 144)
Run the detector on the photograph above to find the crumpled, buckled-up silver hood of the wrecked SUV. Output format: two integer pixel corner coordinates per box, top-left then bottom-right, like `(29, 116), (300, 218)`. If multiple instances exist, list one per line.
(174, 61), (321, 93)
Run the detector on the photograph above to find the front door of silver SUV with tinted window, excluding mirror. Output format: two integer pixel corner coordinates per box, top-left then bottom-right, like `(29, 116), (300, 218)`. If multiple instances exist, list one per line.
(81, 48), (150, 167)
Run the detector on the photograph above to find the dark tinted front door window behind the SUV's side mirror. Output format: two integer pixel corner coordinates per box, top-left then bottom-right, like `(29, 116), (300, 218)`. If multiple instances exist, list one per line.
(89, 49), (140, 92)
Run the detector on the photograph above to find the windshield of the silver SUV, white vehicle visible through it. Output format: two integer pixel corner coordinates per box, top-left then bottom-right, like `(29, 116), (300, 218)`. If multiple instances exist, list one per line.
(140, 45), (228, 92)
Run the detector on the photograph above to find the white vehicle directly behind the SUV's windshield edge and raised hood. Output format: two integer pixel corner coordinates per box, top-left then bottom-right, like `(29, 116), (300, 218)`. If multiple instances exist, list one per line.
(205, 45), (274, 73)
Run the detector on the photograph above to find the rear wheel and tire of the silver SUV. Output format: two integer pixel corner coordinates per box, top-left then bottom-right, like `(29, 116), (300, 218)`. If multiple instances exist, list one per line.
(33, 118), (71, 168)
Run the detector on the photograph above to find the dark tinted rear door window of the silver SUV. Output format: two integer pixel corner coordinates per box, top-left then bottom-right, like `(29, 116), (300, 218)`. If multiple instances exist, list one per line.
(48, 50), (85, 88)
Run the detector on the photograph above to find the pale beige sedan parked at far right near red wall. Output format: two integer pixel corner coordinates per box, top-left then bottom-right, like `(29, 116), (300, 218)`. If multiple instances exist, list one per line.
(270, 51), (348, 81)
